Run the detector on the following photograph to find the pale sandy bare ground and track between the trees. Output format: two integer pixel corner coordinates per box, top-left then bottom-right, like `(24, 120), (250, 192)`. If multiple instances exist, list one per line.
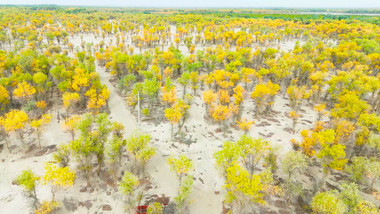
(0, 28), (378, 214)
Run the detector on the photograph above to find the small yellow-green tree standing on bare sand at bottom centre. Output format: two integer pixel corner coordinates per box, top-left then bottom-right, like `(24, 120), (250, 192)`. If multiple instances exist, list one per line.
(167, 155), (193, 182)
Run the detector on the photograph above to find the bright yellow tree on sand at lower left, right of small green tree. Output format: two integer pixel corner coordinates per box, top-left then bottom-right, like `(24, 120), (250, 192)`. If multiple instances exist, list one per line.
(43, 163), (76, 201)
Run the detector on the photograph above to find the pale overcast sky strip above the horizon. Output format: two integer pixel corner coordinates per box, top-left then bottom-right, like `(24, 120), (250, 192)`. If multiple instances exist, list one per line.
(0, 0), (380, 9)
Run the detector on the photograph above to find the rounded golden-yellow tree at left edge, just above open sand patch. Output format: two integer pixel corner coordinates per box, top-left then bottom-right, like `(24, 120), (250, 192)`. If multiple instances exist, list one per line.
(0, 109), (28, 145)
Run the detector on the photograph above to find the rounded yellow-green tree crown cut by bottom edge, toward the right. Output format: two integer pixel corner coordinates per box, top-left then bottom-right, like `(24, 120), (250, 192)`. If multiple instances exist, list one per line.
(311, 191), (347, 214)
